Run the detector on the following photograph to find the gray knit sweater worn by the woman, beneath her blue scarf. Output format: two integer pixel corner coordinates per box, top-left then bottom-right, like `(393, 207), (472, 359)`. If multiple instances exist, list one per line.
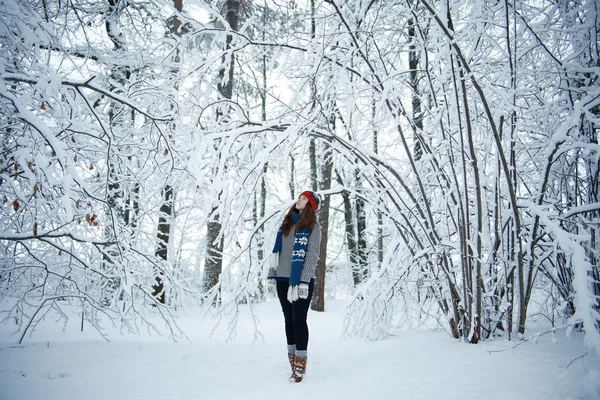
(268, 222), (321, 283)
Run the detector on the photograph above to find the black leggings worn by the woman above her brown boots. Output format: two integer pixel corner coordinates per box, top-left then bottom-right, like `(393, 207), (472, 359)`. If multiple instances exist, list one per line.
(277, 281), (315, 350)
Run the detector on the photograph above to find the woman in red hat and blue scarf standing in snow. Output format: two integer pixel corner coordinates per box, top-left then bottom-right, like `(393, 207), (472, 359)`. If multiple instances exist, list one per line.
(268, 191), (321, 382)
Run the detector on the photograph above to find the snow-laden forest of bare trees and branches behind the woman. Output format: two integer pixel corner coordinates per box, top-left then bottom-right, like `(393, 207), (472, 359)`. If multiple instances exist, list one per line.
(0, 0), (600, 352)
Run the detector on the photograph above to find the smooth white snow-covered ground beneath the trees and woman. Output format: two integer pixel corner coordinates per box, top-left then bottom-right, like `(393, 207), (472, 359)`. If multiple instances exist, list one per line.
(0, 300), (600, 400)
